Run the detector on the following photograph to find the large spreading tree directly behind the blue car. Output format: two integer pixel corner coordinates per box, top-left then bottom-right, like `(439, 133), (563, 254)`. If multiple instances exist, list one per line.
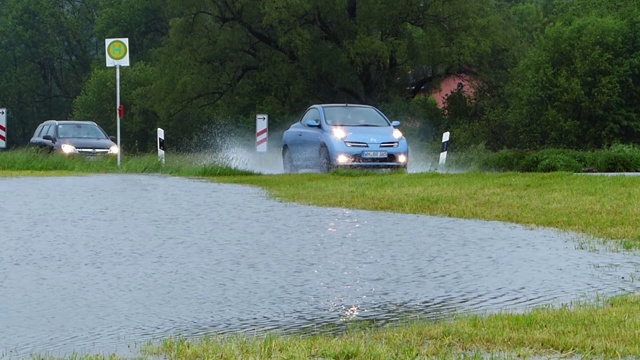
(145, 0), (510, 148)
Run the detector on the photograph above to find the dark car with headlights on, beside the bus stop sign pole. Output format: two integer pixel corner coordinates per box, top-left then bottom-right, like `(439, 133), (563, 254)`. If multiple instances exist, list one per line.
(29, 120), (119, 155)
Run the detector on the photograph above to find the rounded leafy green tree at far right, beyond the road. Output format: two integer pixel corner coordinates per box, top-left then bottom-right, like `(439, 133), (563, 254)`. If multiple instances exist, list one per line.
(508, 1), (640, 149)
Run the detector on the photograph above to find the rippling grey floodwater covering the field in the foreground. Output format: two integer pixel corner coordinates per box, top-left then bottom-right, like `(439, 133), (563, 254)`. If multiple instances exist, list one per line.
(0, 175), (640, 358)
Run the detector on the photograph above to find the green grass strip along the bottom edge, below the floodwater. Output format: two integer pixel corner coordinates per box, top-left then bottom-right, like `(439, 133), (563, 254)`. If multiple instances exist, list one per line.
(135, 296), (640, 359)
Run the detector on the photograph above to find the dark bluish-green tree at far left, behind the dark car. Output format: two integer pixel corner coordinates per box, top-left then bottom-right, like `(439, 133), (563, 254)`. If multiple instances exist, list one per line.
(0, 0), (98, 145)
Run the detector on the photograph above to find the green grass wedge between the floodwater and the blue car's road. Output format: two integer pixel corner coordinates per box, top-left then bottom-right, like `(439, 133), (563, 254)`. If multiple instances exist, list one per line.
(213, 173), (640, 249)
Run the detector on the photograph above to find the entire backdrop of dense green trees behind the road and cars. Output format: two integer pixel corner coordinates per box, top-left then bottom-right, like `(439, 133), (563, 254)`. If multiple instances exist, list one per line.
(0, 0), (640, 152)
